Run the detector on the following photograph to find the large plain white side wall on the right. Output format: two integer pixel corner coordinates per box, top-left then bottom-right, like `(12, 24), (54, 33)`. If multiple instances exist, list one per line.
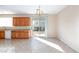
(57, 6), (79, 52)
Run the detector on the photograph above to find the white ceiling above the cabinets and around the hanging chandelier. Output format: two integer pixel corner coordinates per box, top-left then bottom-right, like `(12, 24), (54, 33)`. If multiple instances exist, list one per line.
(0, 5), (66, 14)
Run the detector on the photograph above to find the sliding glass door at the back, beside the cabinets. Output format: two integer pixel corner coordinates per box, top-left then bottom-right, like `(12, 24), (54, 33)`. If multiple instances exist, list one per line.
(32, 16), (47, 36)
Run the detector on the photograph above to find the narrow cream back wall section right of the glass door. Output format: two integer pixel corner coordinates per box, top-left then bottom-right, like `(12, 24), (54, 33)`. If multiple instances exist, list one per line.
(47, 15), (57, 37)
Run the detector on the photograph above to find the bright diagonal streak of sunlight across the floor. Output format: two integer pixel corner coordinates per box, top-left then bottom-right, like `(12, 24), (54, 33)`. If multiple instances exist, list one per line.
(35, 37), (65, 52)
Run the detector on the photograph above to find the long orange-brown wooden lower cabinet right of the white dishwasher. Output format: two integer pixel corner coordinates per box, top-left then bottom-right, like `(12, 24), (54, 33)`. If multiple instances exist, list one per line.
(11, 30), (30, 39)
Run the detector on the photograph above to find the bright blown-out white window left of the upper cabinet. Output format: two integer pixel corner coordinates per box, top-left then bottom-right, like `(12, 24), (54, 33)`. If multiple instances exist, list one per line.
(0, 17), (13, 27)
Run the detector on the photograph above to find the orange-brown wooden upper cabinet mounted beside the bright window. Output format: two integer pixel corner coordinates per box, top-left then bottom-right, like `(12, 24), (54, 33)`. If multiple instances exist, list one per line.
(13, 17), (31, 26)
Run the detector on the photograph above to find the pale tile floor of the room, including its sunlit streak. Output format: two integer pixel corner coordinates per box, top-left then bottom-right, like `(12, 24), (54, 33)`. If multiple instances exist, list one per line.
(0, 37), (76, 53)
